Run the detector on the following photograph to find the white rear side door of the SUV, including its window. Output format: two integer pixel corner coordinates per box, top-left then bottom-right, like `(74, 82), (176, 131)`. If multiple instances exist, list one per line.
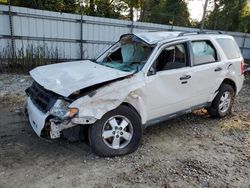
(189, 40), (226, 106)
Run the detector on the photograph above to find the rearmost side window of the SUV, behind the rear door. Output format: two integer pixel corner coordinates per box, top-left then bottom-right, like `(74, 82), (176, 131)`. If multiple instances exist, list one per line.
(216, 38), (241, 59)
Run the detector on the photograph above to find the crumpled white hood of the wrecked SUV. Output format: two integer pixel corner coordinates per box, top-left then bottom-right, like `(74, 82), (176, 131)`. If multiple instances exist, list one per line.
(30, 60), (131, 97)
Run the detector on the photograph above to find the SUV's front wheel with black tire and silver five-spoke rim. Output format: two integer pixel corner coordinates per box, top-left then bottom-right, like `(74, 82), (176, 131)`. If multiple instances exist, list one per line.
(89, 105), (142, 157)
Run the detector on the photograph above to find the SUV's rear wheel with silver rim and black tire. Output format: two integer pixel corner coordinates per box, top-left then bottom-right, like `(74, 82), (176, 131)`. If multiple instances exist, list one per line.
(208, 84), (235, 118)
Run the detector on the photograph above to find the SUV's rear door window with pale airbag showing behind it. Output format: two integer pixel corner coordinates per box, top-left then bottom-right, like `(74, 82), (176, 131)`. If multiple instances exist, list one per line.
(192, 41), (217, 65)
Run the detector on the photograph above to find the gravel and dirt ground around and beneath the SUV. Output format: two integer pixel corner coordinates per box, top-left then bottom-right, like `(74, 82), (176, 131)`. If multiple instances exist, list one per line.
(0, 74), (250, 188)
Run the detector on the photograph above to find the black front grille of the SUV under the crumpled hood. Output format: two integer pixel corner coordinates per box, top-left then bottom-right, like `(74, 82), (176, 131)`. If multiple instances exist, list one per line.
(26, 82), (58, 113)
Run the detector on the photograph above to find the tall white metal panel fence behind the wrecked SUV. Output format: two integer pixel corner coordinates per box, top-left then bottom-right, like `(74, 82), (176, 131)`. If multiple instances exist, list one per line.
(0, 5), (250, 59)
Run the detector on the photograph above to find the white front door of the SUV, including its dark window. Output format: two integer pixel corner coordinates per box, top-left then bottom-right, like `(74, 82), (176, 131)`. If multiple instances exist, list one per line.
(145, 43), (192, 120)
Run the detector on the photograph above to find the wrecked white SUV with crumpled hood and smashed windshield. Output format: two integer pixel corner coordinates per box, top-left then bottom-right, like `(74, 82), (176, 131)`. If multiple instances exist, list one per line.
(26, 32), (244, 156)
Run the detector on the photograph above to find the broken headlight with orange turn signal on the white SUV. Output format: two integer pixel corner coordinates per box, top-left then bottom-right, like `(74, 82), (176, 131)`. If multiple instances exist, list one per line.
(50, 99), (78, 119)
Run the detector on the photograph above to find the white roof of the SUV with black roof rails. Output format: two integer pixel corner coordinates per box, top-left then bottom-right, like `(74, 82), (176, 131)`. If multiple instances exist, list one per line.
(133, 31), (231, 45)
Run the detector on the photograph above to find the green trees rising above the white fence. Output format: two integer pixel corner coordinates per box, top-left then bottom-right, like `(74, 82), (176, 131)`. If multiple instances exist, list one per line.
(6, 0), (250, 32)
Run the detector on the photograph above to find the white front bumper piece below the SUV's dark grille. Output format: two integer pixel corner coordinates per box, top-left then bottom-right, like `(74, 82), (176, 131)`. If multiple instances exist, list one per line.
(26, 97), (49, 137)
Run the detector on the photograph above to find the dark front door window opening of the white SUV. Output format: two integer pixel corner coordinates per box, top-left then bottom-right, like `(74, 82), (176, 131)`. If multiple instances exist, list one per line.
(154, 44), (188, 72)
